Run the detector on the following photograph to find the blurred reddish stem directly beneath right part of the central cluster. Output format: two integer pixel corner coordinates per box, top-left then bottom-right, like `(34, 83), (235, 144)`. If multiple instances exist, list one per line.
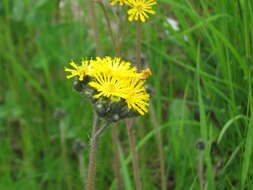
(127, 119), (142, 190)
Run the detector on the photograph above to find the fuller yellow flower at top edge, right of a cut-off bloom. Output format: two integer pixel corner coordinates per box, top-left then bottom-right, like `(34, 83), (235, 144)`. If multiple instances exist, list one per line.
(126, 0), (156, 22)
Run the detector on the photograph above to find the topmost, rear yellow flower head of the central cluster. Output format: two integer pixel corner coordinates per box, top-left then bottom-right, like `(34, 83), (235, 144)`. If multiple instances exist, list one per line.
(90, 57), (139, 80)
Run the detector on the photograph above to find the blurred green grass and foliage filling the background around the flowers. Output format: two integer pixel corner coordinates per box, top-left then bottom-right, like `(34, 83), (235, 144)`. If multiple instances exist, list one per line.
(0, 0), (253, 190)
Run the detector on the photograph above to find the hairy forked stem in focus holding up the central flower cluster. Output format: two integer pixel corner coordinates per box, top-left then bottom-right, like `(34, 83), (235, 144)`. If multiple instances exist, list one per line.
(86, 114), (109, 190)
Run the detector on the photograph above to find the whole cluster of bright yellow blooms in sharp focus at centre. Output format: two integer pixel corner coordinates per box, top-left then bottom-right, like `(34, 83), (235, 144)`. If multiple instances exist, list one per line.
(65, 57), (151, 115)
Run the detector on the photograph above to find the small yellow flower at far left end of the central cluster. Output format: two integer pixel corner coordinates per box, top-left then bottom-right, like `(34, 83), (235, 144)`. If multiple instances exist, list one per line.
(64, 60), (90, 81)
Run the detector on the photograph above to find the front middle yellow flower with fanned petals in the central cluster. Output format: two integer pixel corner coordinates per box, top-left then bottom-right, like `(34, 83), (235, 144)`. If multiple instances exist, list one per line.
(88, 74), (126, 98)
